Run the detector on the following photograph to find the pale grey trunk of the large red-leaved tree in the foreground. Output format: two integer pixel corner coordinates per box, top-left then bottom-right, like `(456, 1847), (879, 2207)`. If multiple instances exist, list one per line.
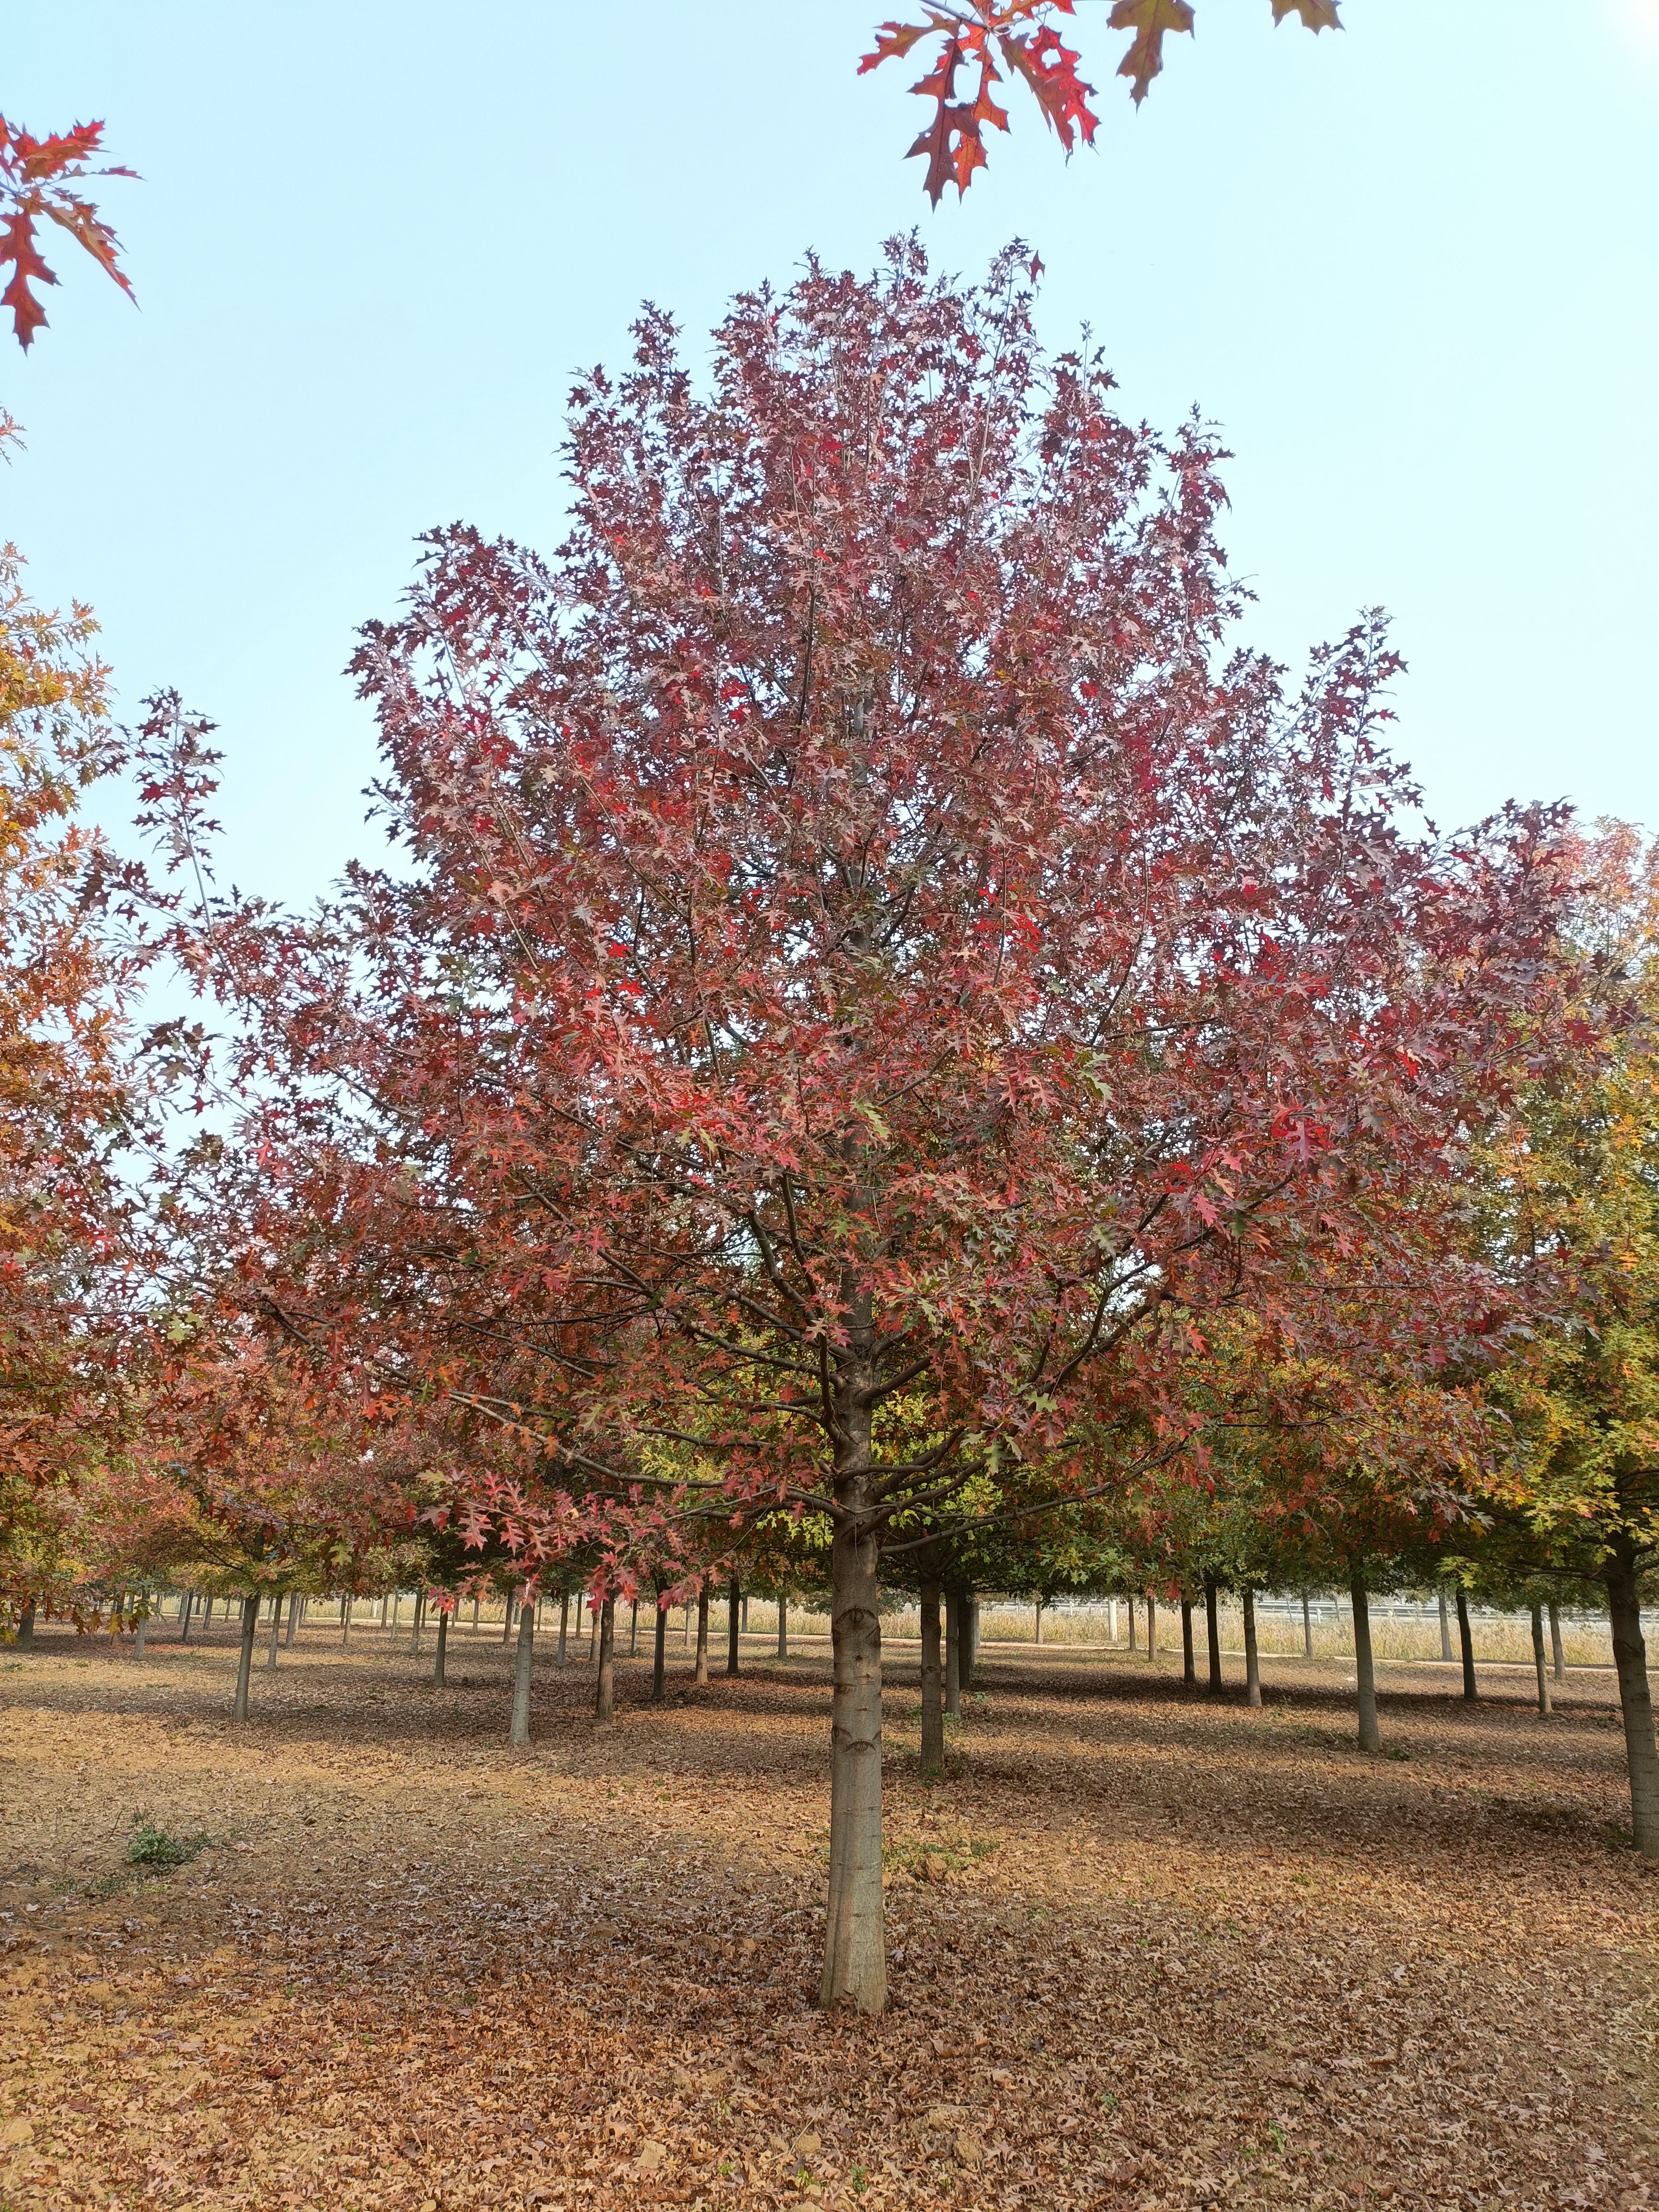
(818, 1424), (887, 2013)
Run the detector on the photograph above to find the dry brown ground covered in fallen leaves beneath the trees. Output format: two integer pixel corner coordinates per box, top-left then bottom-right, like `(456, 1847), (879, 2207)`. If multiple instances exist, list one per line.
(0, 1628), (1659, 2212)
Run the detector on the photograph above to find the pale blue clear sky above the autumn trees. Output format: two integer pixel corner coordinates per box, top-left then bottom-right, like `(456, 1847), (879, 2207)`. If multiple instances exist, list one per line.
(0, 0), (1659, 898)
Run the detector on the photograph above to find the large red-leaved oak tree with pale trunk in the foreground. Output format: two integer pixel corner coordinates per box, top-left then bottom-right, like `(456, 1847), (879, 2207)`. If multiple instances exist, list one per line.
(204, 245), (1559, 2009)
